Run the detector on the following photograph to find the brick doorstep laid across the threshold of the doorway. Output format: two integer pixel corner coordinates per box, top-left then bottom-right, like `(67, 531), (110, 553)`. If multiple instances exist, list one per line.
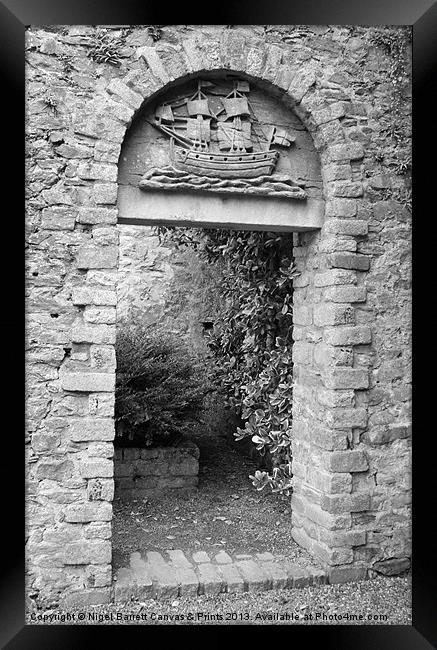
(113, 550), (328, 602)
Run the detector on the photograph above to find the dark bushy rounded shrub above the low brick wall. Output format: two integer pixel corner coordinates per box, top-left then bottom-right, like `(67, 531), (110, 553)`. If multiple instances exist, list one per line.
(115, 323), (209, 447)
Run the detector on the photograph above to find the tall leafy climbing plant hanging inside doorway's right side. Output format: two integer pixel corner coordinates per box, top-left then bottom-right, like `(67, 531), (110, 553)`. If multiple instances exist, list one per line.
(157, 227), (297, 494)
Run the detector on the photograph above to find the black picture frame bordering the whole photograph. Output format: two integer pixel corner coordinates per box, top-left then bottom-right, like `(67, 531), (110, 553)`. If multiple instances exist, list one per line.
(5, 0), (437, 650)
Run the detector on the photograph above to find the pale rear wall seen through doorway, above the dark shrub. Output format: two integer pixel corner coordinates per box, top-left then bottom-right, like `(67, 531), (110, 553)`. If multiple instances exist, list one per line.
(117, 224), (220, 356)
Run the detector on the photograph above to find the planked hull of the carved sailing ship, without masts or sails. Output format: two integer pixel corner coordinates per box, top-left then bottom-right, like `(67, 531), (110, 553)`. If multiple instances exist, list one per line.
(172, 147), (279, 178)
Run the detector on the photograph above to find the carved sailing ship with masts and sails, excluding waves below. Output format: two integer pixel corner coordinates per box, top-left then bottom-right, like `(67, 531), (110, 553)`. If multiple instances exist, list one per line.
(151, 80), (294, 178)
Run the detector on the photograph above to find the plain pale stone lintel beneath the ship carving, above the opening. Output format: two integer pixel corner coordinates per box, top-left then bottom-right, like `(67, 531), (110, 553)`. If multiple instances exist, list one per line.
(118, 186), (324, 232)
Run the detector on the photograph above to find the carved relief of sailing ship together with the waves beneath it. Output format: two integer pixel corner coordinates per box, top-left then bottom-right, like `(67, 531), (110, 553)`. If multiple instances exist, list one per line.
(139, 78), (307, 200)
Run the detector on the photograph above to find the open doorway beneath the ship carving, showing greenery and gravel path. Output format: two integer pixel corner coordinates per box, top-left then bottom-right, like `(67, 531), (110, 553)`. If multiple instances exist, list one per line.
(112, 224), (310, 571)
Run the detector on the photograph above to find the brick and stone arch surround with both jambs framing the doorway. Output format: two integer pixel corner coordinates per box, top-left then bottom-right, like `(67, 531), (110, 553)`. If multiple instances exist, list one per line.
(27, 28), (409, 604)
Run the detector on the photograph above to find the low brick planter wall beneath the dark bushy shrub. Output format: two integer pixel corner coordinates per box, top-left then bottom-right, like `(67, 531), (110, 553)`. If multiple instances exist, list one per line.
(114, 440), (199, 499)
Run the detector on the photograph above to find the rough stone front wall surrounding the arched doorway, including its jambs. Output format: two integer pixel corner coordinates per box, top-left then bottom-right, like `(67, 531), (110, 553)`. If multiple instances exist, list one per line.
(26, 25), (411, 604)
